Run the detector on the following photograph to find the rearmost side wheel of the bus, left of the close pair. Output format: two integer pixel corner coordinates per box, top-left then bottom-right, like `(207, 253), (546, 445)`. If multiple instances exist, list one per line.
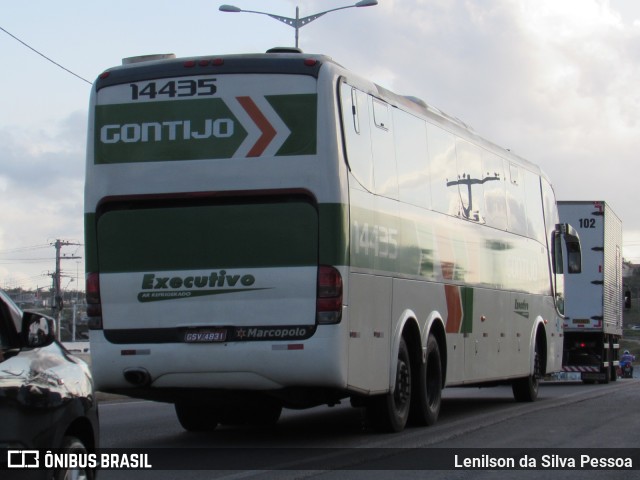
(367, 338), (412, 432)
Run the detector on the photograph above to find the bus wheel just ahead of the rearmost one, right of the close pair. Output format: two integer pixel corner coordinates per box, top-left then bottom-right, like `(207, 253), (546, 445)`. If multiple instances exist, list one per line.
(410, 334), (442, 426)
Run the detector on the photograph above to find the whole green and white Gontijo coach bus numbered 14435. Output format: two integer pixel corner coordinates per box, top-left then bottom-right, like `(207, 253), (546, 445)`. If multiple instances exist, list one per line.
(85, 51), (580, 431)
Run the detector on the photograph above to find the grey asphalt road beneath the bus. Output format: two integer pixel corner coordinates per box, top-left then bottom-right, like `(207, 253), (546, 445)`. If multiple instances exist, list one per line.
(99, 378), (640, 480)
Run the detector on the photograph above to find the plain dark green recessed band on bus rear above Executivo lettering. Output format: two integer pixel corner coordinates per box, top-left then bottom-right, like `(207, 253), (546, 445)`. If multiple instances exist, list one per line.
(97, 203), (318, 273)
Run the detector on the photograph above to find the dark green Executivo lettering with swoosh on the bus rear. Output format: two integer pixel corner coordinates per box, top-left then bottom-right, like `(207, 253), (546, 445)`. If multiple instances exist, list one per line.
(138, 270), (264, 302)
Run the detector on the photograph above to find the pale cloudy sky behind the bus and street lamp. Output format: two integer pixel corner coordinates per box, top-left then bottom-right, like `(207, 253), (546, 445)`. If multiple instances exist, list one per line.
(0, 0), (640, 290)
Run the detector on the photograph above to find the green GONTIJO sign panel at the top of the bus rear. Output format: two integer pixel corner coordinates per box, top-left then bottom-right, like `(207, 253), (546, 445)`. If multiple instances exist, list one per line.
(93, 94), (318, 165)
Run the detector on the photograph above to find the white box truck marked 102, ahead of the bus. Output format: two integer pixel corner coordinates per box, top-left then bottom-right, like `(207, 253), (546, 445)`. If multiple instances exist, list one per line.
(558, 201), (624, 383)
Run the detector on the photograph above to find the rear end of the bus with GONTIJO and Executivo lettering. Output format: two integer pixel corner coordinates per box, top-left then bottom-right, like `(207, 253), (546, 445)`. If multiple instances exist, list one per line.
(85, 50), (346, 418)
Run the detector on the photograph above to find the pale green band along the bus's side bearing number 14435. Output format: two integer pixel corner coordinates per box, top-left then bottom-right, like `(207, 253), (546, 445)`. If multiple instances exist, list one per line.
(349, 202), (549, 294)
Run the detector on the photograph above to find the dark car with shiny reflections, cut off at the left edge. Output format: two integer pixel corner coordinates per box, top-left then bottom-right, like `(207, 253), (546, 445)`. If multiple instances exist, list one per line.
(0, 290), (99, 479)
